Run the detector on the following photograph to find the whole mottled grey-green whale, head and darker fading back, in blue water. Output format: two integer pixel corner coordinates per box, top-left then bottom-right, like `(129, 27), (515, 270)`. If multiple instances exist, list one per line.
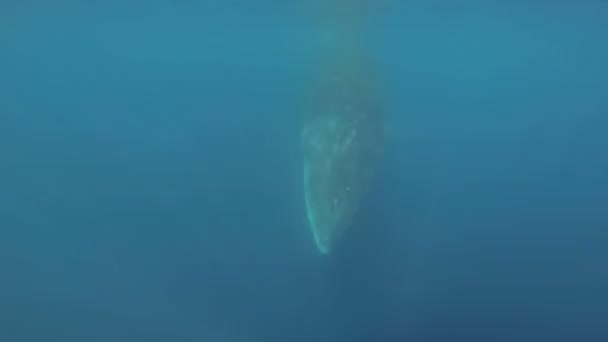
(301, 70), (385, 254)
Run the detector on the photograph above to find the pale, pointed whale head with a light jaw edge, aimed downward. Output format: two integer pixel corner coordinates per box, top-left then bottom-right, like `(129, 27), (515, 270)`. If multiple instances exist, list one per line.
(301, 111), (381, 254)
